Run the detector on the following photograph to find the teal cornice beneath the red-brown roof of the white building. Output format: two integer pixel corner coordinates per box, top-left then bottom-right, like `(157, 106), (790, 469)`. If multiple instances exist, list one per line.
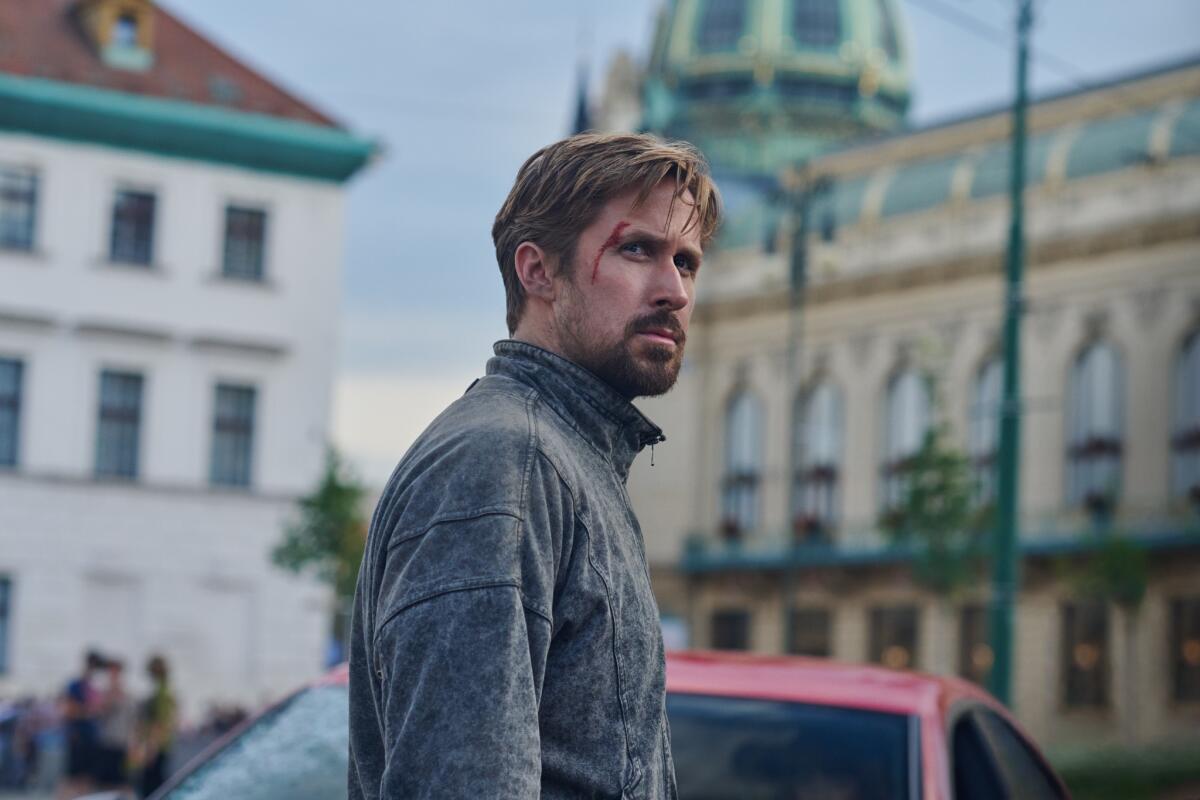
(0, 73), (378, 182)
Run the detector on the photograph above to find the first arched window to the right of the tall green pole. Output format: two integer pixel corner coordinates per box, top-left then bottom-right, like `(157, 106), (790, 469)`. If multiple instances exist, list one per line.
(1067, 342), (1122, 513)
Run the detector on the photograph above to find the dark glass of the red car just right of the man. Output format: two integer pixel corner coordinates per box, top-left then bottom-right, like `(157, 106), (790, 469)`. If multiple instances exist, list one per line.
(667, 694), (914, 800)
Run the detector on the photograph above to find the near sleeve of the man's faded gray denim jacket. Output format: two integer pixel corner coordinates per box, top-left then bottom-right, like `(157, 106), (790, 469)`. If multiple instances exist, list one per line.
(374, 450), (570, 799)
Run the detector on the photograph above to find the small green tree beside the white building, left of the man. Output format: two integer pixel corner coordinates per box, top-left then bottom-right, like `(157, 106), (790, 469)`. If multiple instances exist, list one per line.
(271, 447), (367, 640)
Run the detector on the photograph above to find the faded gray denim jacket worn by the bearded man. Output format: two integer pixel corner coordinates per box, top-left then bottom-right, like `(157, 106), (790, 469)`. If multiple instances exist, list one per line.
(349, 341), (676, 800)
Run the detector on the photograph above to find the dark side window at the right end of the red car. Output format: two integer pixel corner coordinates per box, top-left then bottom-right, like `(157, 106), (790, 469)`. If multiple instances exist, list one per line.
(952, 709), (1066, 800)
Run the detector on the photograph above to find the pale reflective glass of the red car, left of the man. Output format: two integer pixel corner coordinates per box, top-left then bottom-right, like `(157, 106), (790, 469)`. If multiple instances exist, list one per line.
(163, 686), (349, 800)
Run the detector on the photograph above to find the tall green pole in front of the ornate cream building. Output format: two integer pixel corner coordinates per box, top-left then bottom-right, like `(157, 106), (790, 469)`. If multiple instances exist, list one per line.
(989, 0), (1033, 706)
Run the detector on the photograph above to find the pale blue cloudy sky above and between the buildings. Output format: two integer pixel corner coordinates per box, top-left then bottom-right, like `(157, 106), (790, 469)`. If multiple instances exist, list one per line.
(161, 0), (1200, 486)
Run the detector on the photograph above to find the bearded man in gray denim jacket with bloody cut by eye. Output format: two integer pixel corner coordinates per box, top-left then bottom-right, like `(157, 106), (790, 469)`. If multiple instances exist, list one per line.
(349, 134), (719, 799)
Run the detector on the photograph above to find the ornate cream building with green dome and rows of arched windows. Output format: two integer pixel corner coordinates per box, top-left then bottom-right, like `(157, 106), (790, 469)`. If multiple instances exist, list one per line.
(601, 0), (1200, 746)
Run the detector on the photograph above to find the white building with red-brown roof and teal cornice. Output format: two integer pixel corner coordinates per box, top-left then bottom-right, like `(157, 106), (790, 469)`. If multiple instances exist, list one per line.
(0, 0), (372, 715)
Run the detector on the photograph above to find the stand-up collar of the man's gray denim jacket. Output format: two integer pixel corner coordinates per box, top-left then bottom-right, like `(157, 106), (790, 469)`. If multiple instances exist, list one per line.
(487, 339), (666, 480)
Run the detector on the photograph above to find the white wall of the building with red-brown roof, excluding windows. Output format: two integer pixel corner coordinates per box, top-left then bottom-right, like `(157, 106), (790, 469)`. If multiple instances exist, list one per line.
(0, 133), (343, 718)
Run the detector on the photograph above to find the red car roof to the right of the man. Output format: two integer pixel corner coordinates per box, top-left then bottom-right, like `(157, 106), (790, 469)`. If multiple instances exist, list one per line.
(667, 651), (996, 716)
